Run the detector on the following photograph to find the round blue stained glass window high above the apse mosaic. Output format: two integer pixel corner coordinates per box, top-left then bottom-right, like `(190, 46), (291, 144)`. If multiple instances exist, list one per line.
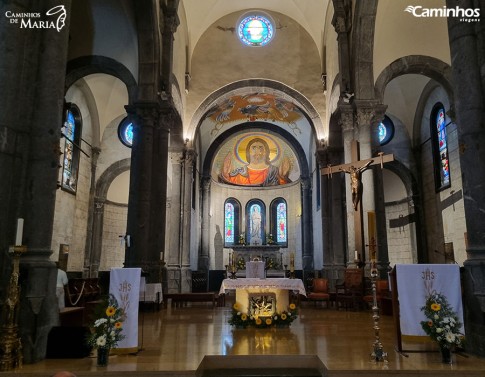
(237, 15), (274, 46)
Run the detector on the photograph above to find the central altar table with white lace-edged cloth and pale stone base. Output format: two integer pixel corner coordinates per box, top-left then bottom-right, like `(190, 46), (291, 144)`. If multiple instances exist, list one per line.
(219, 278), (306, 314)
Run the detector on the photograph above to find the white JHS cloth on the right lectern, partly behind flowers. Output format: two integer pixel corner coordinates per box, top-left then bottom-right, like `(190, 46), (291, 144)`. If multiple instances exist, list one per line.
(396, 264), (465, 336)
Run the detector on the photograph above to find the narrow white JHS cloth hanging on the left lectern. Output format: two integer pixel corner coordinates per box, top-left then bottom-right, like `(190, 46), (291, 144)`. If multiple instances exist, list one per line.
(109, 268), (141, 352)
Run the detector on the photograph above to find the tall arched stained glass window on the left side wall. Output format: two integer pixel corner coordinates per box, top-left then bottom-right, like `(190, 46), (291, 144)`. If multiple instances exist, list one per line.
(61, 103), (82, 193)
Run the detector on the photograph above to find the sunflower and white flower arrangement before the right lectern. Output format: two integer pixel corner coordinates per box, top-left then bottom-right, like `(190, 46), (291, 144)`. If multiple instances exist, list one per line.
(421, 293), (463, 349)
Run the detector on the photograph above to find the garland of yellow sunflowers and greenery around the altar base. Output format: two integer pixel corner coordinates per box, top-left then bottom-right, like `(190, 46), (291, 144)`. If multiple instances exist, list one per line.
(229, 303), (298, 328)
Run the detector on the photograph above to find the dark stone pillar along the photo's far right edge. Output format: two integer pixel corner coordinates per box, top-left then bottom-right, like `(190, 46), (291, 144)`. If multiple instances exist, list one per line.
(446, 0), (485, 356)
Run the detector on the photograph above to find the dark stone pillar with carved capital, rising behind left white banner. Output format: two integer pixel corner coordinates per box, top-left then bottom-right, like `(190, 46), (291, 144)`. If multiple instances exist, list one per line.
(125, 102), (176, 282)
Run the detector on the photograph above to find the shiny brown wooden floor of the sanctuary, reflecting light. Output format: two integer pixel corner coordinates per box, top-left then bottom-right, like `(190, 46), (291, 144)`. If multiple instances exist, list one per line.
(0, 300), (485, 377)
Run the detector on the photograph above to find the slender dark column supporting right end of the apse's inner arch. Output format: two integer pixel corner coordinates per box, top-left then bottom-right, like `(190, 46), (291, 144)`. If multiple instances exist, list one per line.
(301, 177), (313, 272)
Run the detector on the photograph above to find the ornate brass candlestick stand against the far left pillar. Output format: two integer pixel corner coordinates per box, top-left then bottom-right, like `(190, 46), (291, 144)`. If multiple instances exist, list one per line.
(0, 245), (27, 371)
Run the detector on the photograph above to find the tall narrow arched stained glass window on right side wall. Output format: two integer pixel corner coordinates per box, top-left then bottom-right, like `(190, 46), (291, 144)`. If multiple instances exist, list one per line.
(431, 103), (451, 191)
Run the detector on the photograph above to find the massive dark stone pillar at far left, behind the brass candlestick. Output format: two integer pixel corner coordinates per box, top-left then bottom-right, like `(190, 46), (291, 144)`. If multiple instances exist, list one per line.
(0, 0), (71, 363)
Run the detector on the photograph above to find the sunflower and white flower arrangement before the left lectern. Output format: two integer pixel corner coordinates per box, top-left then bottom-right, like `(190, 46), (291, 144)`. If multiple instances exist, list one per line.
(87, 294), (125, 349)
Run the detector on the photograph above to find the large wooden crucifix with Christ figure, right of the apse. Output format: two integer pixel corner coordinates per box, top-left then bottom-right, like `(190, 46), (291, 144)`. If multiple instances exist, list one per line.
(320, 140), (394, 265)
